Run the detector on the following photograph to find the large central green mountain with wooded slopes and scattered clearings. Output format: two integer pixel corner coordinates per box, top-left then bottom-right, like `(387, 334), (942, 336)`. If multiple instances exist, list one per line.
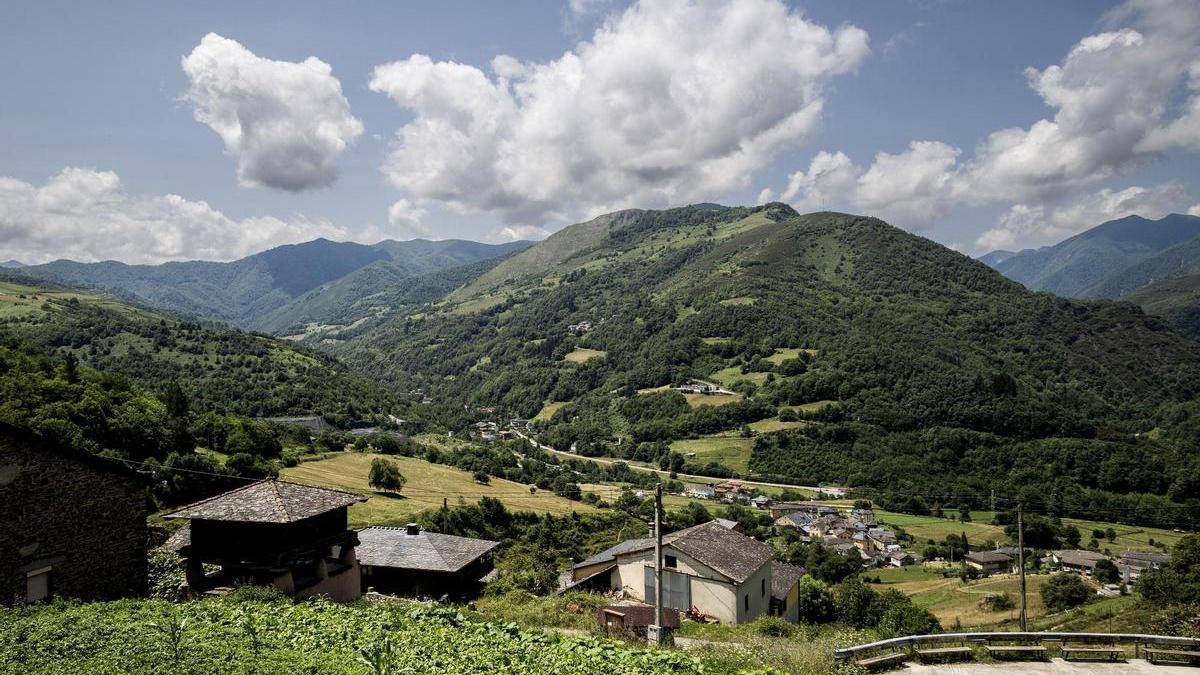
(337, 204), (1200, 526)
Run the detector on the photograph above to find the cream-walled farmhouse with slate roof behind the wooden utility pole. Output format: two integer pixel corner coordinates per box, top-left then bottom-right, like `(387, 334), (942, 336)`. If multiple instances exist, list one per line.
(571, 520), (798, 623)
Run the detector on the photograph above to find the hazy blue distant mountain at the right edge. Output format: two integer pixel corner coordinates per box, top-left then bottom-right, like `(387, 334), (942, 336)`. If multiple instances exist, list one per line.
(990, 214), (1200, 298)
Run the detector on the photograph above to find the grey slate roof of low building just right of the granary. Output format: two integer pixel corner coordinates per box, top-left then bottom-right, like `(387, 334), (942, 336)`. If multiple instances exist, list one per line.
(355, 527), (500, 572)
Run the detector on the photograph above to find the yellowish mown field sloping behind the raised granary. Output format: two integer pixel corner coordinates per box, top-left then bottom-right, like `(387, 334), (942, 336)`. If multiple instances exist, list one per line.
(280, 453), (595, 527)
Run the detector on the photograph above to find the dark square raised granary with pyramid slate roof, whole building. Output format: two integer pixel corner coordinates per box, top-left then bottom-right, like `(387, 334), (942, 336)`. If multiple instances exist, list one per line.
(166, 479), (366, 602)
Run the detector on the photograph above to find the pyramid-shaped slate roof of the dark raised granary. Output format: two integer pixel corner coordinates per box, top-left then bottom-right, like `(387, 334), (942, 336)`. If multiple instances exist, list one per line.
(164, 479), (367, 524)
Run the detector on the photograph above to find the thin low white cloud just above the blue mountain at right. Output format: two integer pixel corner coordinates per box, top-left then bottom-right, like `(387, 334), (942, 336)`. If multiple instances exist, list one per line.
(976, 183), (1188, 251)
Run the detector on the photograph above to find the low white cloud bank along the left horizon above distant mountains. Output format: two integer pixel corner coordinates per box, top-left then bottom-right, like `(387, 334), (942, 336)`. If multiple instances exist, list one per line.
(0, 167), (349, 263)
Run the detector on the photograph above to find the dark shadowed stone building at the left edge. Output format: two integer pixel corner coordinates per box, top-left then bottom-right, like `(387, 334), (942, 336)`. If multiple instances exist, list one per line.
(0, 425), (151, 605)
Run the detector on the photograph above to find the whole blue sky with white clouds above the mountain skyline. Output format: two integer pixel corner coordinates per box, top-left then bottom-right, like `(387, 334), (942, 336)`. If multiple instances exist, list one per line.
(0, 0), (1200, 263)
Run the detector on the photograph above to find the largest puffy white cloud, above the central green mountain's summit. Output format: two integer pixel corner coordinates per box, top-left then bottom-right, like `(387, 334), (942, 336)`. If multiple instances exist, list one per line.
(370, 0), (869, 225)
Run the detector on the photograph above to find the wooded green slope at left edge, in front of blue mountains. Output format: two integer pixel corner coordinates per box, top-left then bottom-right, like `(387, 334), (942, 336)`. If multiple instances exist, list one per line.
(0, 273), (406, 422)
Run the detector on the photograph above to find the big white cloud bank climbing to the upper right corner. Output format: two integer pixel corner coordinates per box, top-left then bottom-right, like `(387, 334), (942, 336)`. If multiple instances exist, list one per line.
(785, 0), (1200, 247)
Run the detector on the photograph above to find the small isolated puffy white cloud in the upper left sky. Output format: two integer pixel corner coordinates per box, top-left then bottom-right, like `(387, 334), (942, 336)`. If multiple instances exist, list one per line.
(182, 32), (362, 191)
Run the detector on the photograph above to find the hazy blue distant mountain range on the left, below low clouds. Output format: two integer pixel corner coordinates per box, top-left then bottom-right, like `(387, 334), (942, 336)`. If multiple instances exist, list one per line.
(23, 239), (528, 330)
